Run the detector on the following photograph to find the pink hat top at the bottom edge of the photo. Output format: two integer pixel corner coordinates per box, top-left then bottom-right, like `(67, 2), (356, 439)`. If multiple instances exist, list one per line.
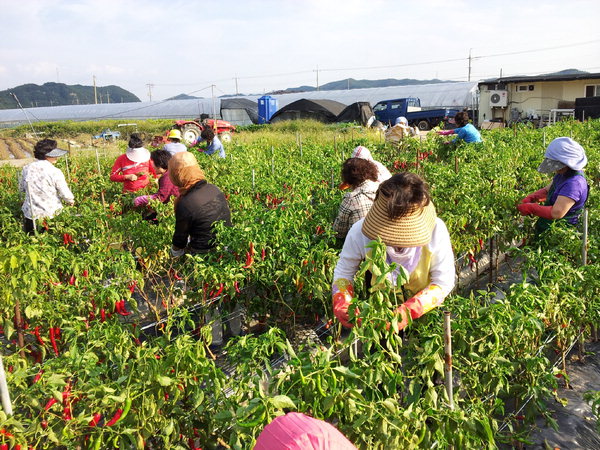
(254, 413), (356, 450)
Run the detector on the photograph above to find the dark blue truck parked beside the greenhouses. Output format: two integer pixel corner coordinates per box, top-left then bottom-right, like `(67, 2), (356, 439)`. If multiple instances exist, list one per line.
(373, 97), (460, 131)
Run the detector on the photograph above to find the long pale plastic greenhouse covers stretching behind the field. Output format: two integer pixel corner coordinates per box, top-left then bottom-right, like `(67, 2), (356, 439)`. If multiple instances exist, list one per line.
(0, 82), (478, 126)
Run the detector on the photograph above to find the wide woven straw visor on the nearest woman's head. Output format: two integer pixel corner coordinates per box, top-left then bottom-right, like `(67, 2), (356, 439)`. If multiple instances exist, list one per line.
(362, 194), (437, 248)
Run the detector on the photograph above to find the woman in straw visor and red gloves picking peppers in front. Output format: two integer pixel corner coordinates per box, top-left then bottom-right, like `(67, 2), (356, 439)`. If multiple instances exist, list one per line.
(332, 172), (455, 331)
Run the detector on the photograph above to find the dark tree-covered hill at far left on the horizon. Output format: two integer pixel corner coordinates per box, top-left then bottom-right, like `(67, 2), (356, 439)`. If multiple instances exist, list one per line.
(0, 83), (140, 109)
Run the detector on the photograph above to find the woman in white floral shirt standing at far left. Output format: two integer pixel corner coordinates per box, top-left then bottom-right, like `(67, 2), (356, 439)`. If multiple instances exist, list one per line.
(19, 139), (75, 233)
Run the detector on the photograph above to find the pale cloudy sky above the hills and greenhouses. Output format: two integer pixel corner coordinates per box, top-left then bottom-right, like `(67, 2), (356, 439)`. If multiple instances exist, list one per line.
(0, 0), (600, 101)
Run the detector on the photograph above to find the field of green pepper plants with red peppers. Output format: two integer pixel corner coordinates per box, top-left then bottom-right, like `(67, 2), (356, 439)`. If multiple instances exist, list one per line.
(0, 120), (600, 449)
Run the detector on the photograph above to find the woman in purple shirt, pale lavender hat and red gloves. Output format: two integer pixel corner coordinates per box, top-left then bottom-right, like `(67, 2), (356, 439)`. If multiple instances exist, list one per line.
(517, 137), (589, 234)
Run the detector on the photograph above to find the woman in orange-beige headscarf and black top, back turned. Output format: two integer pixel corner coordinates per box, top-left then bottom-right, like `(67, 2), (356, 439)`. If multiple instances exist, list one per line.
(169, 152), (231, 256)
